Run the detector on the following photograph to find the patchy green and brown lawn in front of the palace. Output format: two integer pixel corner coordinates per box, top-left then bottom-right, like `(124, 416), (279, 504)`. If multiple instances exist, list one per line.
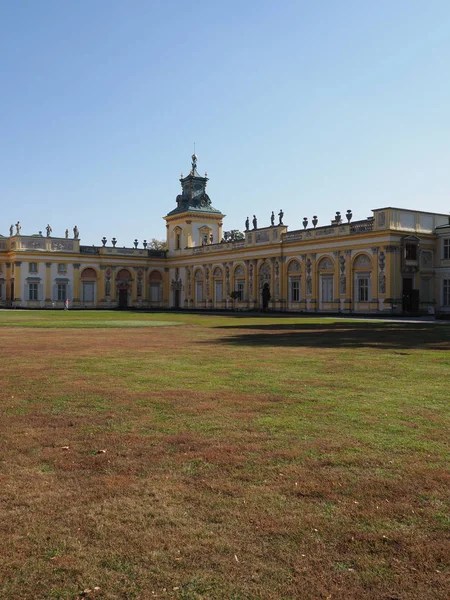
(0, 310), (450, 600)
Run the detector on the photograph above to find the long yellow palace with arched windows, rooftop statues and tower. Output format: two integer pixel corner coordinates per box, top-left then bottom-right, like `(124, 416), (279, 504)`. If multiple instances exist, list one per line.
(0, 155), (450, 314)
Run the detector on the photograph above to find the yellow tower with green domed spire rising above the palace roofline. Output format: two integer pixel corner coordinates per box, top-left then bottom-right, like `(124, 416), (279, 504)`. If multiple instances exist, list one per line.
(164, 154), (225, 253)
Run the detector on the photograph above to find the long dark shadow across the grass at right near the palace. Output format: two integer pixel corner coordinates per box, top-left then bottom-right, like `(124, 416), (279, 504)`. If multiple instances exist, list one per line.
(211, 321), (450, 350)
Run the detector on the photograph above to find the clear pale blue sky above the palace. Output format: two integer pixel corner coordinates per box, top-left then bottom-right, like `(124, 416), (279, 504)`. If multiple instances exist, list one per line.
(0, 0), (450, 246)
